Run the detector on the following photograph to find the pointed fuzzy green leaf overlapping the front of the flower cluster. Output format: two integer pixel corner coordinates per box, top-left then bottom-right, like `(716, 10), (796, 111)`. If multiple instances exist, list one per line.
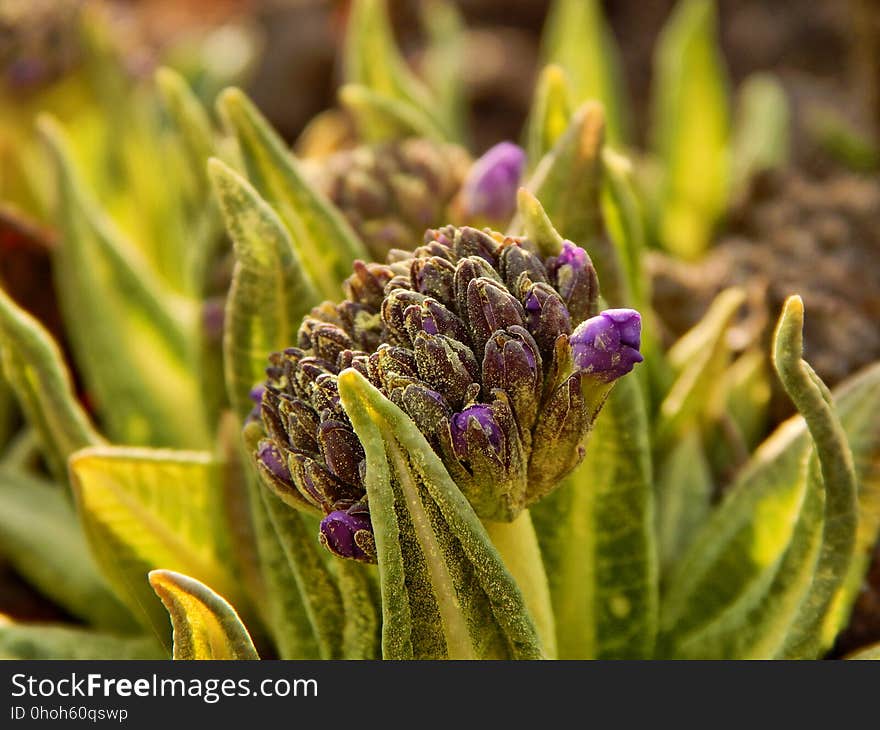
(339, 370), (543, 659)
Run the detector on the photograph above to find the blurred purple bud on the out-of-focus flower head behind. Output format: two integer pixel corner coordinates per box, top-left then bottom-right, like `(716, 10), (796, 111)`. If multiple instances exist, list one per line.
(462, 142), (526, 221)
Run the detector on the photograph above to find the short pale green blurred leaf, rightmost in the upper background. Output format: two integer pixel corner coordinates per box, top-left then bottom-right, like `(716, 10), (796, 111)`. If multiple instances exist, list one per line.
(731, 73), (791, 198)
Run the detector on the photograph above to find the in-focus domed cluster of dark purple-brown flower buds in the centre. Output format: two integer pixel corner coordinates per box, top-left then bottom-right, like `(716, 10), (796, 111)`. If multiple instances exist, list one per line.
(256, 226), (641, 560)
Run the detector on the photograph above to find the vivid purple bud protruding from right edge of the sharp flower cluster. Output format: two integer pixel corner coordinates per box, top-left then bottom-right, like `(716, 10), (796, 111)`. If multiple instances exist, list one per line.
(569, 309), (644, 382)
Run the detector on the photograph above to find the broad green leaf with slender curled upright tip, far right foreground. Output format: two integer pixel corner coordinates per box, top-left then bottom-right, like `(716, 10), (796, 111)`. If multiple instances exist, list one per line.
(661, 298), (856, 659)
